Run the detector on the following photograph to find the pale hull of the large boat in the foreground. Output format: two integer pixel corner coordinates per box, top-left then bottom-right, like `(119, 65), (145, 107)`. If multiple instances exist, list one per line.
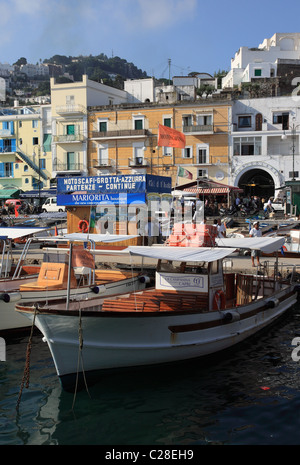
(18, 286), (297, 390)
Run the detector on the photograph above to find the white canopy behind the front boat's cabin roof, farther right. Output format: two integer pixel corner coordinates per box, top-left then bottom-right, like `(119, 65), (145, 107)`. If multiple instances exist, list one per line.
(216, 237), (285, 253)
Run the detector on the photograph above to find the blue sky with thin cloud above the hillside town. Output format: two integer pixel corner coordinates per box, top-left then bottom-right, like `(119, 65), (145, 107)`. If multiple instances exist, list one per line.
(0, 0), (300, 78)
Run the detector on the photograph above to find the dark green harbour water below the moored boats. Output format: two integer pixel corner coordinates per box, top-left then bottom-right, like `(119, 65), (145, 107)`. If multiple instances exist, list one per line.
(0, 304), (300, 448)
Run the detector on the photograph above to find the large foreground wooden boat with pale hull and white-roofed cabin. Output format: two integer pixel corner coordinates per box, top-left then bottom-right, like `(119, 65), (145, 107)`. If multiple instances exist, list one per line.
(16, 238), (297, 391)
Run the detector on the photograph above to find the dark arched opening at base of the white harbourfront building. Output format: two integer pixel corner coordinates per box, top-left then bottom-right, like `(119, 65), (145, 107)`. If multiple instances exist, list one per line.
(238, 169), (275, 199)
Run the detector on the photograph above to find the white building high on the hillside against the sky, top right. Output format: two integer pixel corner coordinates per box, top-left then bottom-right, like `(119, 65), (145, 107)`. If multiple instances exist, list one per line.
(222, 32), (300, 89)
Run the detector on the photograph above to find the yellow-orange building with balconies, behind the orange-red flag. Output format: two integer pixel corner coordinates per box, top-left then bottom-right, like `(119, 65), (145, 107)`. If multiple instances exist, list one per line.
(88, 100), (231, 186)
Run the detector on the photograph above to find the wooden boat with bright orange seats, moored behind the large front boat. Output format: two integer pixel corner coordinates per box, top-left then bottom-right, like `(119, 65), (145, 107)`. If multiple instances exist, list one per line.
(0, 235), (148, 332)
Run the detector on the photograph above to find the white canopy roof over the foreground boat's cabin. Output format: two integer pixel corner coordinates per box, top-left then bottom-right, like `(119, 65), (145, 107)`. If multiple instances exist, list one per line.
(128, 246), (235, 262)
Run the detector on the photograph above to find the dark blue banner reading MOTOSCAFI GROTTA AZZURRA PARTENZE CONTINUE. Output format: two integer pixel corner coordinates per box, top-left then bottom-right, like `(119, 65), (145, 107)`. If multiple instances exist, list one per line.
(57, 174), (172, 195)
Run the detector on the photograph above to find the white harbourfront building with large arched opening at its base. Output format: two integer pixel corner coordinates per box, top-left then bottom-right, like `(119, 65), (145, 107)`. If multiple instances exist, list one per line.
(229, 96), (300, 197)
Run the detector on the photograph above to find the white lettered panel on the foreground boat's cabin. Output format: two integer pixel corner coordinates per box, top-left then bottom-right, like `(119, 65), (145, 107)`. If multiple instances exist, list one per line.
(155, 272), (208, 292)
